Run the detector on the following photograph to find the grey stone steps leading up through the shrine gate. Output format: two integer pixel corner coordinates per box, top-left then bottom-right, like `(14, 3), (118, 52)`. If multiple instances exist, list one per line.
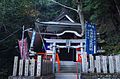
(55, 61), (77, 79)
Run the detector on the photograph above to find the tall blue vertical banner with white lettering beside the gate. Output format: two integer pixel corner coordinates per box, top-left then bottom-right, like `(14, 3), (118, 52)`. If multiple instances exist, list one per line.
(86, 23), (96, 54)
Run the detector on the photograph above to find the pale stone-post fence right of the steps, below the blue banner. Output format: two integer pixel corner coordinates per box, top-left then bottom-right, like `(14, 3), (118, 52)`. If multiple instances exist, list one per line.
(81, 54), (120, 79)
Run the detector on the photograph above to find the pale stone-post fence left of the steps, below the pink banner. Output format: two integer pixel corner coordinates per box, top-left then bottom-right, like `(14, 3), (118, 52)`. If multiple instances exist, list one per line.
(9, 56), (53, 79)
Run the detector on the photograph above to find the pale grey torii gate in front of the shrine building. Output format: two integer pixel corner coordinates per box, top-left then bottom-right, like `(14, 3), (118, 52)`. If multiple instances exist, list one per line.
(44, 39), (86, 73)
